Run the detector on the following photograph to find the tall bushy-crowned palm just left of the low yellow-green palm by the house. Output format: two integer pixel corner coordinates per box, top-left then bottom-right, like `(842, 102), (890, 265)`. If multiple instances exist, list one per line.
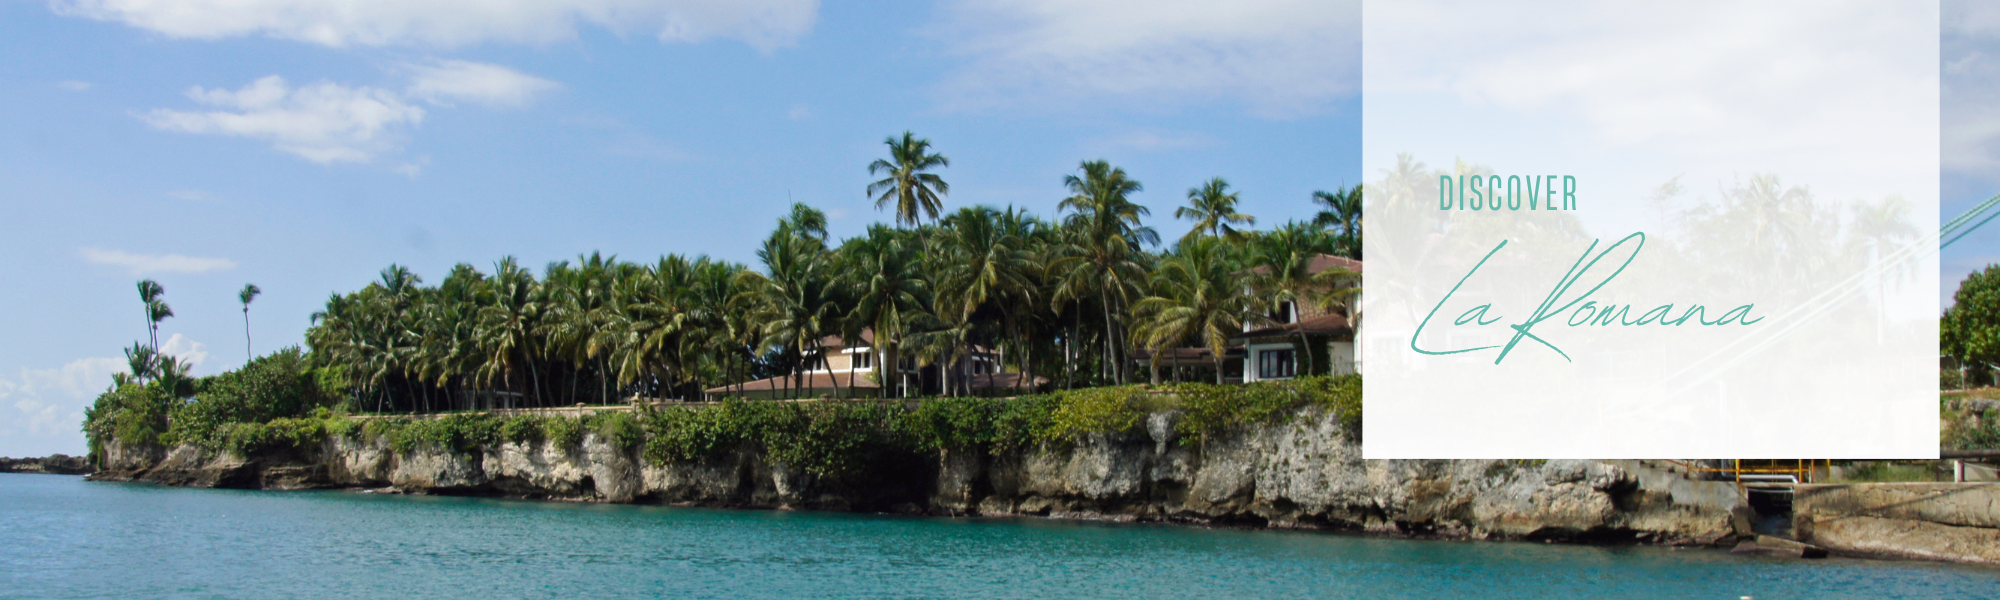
(1048, 160), (1160, 384)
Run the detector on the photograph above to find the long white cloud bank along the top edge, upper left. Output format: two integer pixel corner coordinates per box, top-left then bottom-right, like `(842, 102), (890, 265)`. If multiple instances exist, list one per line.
(52, 0), (820, 52)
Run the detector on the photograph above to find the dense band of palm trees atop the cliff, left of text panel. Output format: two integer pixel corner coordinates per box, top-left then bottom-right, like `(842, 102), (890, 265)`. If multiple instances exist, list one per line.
(286, 132), (1360, 412)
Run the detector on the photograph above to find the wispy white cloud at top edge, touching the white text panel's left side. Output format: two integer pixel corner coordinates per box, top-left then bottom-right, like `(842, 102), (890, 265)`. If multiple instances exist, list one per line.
(942, 0), (1360, 116)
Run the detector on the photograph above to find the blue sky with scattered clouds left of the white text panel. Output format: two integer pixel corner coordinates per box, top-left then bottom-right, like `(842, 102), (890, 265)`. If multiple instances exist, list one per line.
(0, 0), (1360, 456)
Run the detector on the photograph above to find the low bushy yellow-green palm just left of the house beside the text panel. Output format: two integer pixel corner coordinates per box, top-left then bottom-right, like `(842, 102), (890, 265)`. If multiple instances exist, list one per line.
(1132, 236), (1258, 384)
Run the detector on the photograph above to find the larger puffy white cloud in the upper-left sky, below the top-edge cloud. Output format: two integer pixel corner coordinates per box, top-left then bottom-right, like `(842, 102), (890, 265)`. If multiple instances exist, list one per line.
(142, 76), (424, 164)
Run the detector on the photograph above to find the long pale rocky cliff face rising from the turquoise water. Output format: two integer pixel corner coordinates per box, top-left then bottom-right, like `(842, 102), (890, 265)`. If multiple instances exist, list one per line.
(94, 408), (1738, 544)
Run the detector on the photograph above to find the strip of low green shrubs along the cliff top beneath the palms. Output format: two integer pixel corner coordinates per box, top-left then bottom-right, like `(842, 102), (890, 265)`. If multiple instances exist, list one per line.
(86, 376), (1362, 476)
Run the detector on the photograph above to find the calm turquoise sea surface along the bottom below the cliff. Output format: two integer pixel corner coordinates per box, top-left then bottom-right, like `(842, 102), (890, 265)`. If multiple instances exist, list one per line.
(0, 474), (2000, 600)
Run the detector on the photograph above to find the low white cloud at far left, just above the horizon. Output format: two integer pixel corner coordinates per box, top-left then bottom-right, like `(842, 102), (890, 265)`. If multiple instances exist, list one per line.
(0, 358), (124, 456)
